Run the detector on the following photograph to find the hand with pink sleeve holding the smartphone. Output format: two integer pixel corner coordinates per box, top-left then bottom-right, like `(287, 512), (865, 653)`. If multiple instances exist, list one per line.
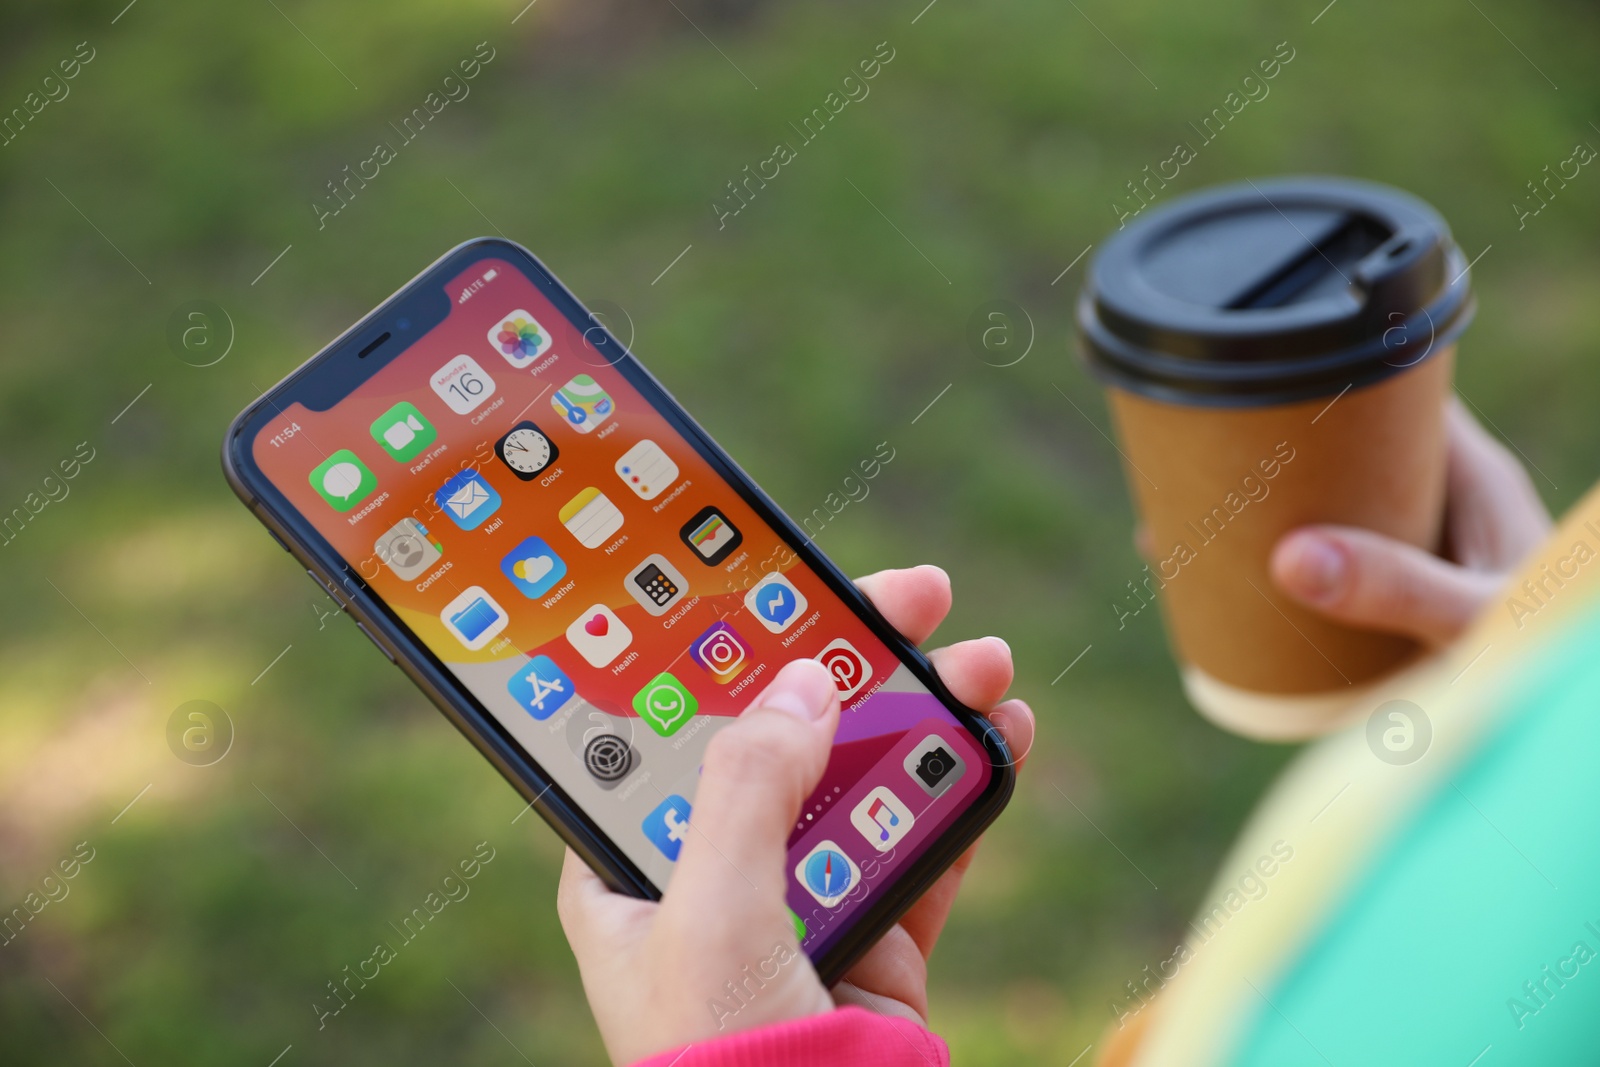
(558, 566), (1034, 1064)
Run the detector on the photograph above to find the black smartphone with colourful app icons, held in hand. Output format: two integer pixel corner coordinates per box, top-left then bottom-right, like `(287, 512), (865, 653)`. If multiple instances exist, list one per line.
(222, 238), (1014, 982)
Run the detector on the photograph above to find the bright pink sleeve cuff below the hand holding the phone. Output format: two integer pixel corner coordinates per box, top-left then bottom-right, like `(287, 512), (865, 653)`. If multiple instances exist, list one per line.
(634, 1008), (950, 1067)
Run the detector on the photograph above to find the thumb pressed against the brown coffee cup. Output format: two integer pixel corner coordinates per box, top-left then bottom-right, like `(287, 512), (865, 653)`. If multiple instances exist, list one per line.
(1270, 526), (1501, 645)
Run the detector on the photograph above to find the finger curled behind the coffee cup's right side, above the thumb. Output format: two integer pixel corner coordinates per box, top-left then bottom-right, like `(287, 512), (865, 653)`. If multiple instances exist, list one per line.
(1445, 397), (1550, 571)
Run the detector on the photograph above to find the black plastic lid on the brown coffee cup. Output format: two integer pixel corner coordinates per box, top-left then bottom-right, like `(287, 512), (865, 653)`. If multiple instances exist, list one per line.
(1077, 178), (1475, 406)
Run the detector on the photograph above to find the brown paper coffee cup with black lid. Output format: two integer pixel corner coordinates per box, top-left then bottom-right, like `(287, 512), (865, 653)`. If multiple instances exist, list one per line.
(1077, 178), (1474, 739)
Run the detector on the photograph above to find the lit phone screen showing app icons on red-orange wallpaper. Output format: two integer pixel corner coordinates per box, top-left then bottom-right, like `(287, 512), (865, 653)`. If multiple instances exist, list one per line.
(248, 258), (994, 957)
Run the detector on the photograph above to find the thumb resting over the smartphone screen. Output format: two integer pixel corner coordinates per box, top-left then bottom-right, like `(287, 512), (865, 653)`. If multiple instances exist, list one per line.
(667, 659), (838, 913)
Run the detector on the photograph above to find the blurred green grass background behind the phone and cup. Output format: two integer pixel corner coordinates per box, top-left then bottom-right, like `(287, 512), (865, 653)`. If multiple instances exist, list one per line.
(0, 0), (1600, 1065)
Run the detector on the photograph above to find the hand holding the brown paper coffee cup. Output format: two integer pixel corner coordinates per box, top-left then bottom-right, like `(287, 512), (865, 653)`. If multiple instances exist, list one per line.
(1272, 397), (1550, 646)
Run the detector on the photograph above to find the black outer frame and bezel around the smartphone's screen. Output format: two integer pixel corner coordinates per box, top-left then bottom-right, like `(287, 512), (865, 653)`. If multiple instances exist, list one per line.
(222, 237), (1016, 985)
